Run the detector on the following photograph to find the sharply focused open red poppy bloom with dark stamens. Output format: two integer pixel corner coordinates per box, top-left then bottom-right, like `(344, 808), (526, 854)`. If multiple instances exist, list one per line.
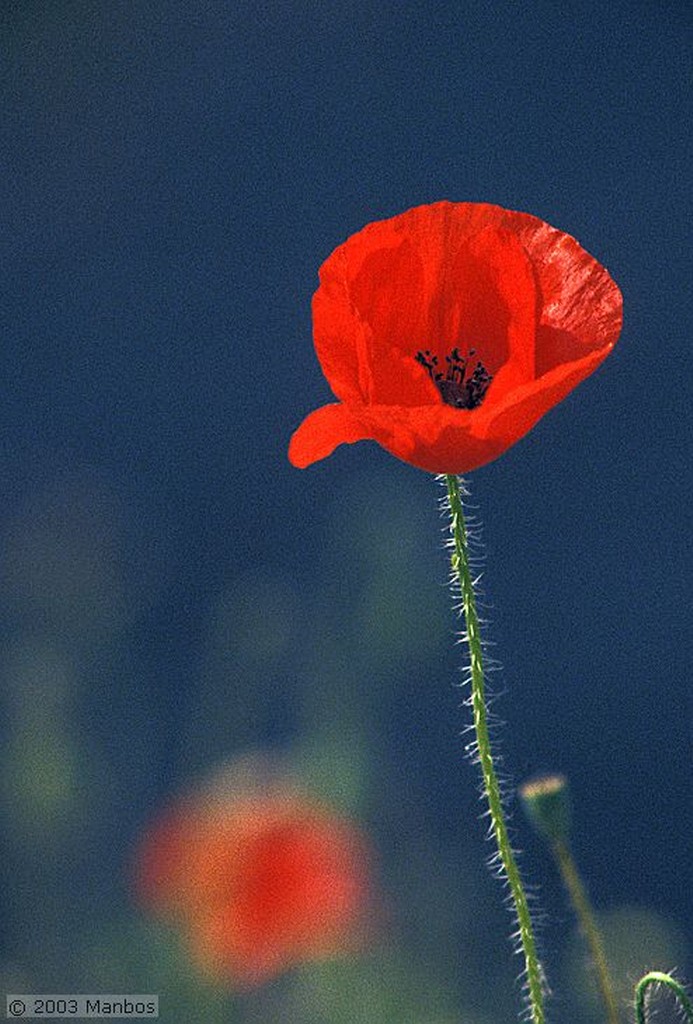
(289, 202), (622, 473)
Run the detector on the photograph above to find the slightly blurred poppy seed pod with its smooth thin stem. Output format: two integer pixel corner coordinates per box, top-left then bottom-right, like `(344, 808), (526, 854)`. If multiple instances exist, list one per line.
(520, 775), (618, 1024)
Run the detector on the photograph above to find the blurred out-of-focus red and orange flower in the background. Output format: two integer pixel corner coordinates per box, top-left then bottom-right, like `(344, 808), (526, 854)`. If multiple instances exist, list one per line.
(135, 765), (374, 988)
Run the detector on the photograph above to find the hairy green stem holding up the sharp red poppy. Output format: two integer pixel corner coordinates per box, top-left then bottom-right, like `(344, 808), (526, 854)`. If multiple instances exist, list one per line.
(445, 475), (546, 1024)
